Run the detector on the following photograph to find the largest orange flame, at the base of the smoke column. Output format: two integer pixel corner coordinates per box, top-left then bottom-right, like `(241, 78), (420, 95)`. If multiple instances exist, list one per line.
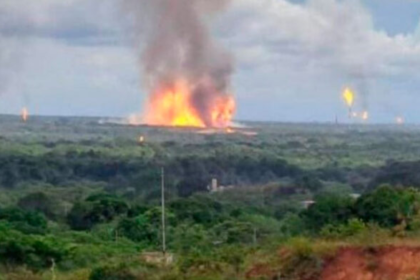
(144, 81), (236, 128)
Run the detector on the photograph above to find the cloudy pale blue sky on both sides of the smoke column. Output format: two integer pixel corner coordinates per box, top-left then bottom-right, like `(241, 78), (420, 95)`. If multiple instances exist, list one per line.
(0, 0), (420, 123)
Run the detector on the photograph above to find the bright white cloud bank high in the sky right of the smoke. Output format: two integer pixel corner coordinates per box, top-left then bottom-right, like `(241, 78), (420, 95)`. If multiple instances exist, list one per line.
(225, 0), (420, 76)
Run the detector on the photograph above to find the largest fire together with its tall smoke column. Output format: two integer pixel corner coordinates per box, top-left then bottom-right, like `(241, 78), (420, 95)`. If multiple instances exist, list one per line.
(125, 0), (236, 129)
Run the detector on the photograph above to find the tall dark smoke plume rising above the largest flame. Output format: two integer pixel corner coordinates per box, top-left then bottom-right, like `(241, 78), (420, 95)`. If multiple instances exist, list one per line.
(124, 0), (233, 125)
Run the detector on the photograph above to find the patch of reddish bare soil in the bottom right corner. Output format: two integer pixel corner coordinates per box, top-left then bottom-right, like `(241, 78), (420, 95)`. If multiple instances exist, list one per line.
(321, 246), (420, 280)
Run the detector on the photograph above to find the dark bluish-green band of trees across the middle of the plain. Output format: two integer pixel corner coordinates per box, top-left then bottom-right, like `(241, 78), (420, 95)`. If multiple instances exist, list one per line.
(0, 151), (303, 196)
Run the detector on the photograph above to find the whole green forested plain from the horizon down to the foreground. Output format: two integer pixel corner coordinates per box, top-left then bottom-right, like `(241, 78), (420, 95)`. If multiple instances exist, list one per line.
(0, 116), (420, 280)
